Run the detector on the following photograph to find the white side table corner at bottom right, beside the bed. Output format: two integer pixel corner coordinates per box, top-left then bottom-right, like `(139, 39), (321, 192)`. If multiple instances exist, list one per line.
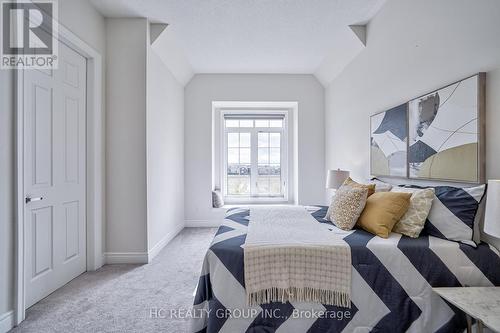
(432, 287), (500, 333)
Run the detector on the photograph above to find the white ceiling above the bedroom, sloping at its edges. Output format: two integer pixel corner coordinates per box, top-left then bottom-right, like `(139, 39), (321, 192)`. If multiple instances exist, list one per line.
(91, 0), (385, 73)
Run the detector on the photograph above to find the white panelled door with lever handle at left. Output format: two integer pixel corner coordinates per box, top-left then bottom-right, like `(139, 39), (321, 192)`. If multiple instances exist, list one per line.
(23, 43), (87, 307)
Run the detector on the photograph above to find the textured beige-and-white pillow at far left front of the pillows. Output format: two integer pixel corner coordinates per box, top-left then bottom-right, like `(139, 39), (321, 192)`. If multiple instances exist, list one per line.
(329, 186), (368, 230)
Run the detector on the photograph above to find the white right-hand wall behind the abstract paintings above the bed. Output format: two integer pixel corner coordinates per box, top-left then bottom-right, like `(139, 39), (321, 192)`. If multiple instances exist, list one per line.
(325, 0), (500, 244)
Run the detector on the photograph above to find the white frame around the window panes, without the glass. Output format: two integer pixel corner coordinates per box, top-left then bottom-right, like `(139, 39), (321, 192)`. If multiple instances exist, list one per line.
(219, 109), (290, 204)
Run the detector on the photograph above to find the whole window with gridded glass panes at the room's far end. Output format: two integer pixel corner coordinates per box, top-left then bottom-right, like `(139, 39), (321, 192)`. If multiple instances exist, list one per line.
(221, 111), (288, 201)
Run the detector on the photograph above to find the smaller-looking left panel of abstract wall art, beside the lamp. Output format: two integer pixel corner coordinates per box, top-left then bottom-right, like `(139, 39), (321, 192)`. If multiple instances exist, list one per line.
(370, 104), (408, 177)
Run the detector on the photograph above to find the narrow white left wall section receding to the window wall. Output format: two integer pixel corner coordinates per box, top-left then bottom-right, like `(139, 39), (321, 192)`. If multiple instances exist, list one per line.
(146, 36), (184, 254)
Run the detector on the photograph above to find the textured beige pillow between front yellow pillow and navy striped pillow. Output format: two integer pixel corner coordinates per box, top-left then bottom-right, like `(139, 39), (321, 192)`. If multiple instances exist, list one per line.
(391, 187), (434, 238)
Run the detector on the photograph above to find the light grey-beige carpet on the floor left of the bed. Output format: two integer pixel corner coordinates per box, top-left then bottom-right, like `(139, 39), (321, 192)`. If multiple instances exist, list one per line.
(11, 228), (216, 333)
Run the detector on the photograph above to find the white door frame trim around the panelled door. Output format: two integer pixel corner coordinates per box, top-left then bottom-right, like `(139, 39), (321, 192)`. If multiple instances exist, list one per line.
(14, 23), (105, 325)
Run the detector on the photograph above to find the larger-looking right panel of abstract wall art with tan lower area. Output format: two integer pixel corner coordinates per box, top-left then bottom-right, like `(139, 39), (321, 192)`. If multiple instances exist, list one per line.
(408, 75), (482, 182)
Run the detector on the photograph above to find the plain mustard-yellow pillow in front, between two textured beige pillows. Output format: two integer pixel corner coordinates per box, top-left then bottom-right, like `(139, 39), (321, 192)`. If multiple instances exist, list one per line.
(357, 192), (411, 238)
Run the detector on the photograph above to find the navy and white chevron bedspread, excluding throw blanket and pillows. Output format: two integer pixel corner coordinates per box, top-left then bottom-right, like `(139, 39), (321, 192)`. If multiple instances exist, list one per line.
(191, 206), (500, 333)
